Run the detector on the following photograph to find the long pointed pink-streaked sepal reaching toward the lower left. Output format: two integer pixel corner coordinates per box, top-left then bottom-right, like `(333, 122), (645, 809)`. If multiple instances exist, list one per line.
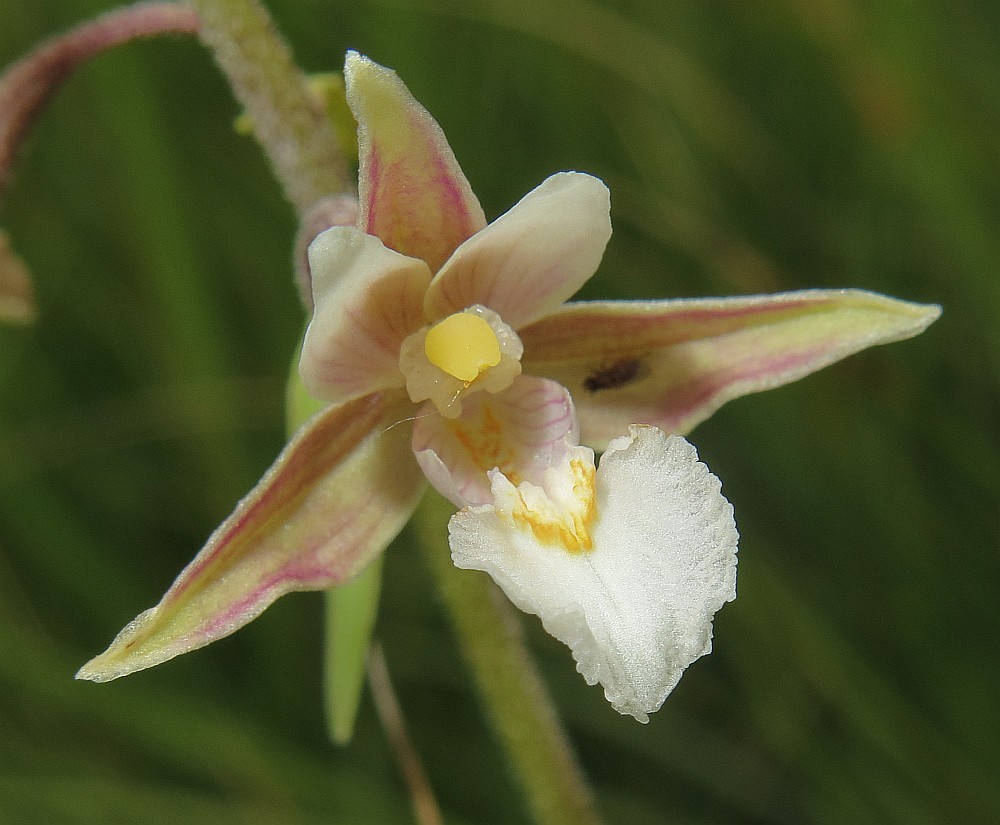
(77, 393), (424, 682)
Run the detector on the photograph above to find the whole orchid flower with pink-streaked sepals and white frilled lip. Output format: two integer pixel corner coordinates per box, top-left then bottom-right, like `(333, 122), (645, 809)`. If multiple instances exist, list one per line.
(78, 53), (939, 721)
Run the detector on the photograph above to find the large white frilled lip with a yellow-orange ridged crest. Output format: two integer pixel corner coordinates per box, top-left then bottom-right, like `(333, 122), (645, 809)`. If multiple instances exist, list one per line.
(449, 427), (738, 722)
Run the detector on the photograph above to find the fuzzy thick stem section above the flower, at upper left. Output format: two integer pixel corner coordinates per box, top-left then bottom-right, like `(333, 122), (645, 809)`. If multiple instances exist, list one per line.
(188, 0), (355, 218)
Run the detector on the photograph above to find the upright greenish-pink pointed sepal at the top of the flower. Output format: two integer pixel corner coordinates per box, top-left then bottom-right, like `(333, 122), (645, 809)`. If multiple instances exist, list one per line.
(344, 52), (486, 272)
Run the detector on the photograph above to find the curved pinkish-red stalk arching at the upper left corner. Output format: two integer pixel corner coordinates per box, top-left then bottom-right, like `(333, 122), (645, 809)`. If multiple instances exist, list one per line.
(0, 3), (198, 200)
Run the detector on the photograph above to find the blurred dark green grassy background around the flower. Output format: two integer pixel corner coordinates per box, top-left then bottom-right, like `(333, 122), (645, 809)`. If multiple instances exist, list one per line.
(0, 0), (1000, 825)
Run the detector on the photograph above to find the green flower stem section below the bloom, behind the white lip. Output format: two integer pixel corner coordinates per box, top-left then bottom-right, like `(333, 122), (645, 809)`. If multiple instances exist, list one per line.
(414, 491), (600, 825)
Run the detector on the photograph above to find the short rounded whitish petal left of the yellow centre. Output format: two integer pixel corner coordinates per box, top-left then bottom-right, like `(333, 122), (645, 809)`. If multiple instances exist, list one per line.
(299, 227), (431, 403)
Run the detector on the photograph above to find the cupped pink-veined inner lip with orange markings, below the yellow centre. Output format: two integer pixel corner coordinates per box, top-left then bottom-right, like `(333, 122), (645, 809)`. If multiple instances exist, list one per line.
(413, 375), (578, 507)
